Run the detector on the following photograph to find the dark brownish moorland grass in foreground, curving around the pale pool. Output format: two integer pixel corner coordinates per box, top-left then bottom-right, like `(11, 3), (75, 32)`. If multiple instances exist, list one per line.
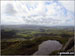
(2, 37), (67, 55)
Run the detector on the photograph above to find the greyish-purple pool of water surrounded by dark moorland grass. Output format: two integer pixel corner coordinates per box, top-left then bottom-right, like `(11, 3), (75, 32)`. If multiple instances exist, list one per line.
(34, 40), (62, 55)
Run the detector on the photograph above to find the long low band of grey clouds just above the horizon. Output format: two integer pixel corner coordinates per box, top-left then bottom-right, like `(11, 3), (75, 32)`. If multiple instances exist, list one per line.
(23, 18), (62, 24)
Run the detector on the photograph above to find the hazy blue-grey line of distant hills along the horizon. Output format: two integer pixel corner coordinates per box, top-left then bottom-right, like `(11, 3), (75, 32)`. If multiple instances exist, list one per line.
(1, 25), (74, 29)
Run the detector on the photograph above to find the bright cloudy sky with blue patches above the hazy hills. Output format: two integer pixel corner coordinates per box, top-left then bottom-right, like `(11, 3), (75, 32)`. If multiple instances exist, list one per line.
(1, 0), (75, 26)
